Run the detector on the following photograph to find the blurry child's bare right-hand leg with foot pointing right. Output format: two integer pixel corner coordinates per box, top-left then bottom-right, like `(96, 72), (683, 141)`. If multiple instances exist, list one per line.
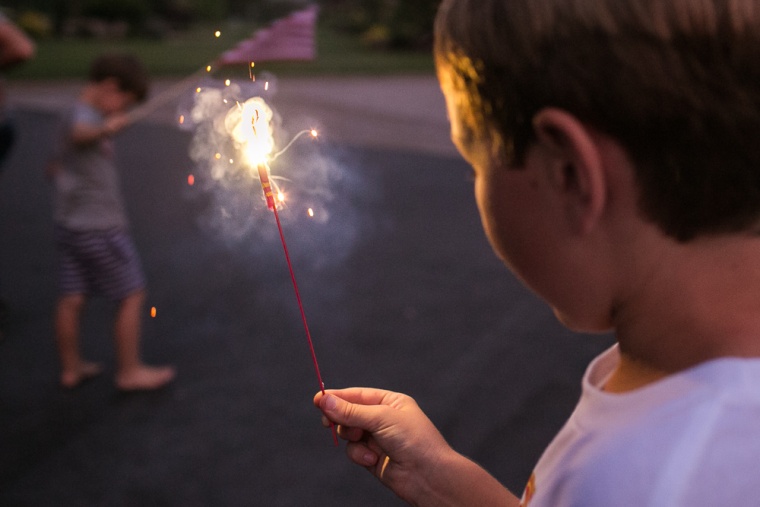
(114, 291), (174, 391)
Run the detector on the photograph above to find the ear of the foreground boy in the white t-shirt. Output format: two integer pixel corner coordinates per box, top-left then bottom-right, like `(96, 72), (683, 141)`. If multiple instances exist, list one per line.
(533, 108), (607, 235)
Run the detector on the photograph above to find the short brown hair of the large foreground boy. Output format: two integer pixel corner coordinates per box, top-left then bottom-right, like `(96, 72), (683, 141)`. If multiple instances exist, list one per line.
(435, 0), (760, 241)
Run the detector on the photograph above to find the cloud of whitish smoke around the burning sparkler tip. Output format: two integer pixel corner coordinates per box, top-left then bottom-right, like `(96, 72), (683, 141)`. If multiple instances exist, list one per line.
(179, 76), (378, 268)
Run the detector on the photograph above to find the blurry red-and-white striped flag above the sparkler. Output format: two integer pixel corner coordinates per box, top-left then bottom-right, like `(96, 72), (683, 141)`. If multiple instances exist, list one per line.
(217, 5), (319, 65)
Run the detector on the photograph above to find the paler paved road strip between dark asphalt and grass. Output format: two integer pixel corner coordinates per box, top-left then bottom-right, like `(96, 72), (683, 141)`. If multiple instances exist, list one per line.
(8, 76), (456, 156)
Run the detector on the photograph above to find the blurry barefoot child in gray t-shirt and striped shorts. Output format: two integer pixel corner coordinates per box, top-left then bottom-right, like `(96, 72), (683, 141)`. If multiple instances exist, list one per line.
(51, 54), (174, 391)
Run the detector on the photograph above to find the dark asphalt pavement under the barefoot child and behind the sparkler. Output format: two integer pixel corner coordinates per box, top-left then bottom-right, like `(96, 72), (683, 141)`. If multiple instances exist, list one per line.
(0, 78), (610, 507)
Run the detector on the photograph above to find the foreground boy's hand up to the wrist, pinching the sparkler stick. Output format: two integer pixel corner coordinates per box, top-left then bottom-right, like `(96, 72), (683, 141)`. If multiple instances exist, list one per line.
(314, 388), (453, 503)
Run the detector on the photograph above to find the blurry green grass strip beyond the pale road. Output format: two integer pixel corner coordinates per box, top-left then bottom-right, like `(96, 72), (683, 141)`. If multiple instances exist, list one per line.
(8, 24), (433, 80)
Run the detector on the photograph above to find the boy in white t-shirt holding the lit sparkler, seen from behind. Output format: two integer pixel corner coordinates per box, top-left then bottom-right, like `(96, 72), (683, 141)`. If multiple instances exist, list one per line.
(315, 0), (760, 507)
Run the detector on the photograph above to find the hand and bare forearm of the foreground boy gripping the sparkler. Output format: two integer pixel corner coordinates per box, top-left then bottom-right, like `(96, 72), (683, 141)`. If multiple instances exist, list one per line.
(314, 387), (520, 507)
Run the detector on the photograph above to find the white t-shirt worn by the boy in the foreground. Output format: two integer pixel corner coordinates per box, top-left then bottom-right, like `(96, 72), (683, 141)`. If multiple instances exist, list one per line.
(523, 346), (760, 507)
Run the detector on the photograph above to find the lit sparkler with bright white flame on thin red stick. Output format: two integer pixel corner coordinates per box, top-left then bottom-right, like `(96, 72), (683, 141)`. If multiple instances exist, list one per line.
(232, 97), (338, 446)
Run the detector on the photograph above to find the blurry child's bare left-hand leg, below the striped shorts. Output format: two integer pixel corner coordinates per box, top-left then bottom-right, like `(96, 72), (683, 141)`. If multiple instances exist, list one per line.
(54, 294), (102, 388)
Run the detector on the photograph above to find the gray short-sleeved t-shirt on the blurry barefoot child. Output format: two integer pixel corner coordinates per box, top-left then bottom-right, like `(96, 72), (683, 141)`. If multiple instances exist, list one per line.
(53, 103), (128, 231)
